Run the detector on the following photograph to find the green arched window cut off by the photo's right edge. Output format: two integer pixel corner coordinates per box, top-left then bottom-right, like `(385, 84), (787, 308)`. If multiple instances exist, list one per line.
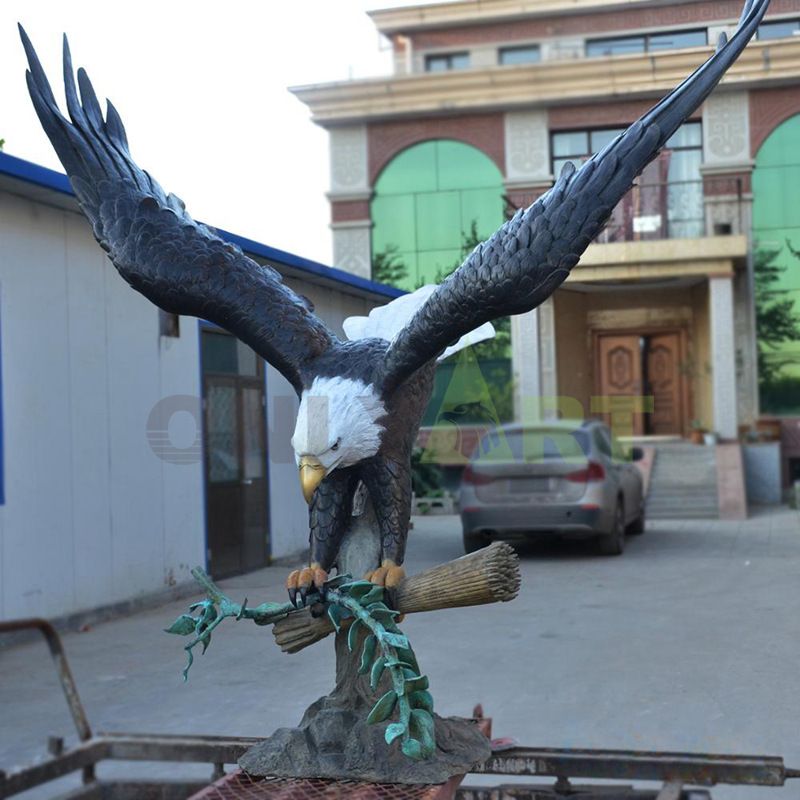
(753, 114), (800, 414)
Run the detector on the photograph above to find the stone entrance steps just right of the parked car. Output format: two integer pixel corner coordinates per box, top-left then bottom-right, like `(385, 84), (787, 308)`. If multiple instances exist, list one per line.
(646, 442), (720, 519)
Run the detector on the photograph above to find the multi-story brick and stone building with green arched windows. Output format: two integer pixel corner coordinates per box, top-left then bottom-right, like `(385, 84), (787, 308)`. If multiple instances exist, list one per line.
(294, 0), (800, 494)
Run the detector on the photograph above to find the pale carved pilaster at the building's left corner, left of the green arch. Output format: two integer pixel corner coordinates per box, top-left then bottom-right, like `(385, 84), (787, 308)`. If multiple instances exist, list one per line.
(328, 125), (372, 278)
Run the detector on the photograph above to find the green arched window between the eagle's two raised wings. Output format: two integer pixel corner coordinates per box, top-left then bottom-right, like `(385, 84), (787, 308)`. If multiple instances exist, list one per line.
(371, 139), (503, 289)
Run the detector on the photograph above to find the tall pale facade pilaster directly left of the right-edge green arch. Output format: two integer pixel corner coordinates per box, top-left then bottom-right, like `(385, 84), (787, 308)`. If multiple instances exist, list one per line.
(702, 88), (758, 422)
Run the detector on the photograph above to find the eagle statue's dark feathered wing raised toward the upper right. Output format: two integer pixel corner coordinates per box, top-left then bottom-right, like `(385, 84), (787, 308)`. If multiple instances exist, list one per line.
(383, 0), (769, 392)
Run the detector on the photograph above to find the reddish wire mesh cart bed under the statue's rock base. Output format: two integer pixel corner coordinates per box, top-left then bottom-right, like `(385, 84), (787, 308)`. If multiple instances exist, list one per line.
(190, 770), (445, 800)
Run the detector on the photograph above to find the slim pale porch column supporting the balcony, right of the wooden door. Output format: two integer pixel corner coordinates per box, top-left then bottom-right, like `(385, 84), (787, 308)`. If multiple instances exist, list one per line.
(708, 275), (739, 439)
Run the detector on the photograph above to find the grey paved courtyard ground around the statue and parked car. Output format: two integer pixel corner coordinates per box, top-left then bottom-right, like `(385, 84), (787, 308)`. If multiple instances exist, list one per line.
(0, 509), (800, 800)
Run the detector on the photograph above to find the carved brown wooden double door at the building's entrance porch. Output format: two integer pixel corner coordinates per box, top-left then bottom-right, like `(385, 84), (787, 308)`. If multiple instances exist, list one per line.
(595, 330), (688, 436)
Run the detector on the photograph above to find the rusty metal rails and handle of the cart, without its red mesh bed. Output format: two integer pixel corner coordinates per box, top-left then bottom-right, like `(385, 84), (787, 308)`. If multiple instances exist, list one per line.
(0, 619), (800, 800)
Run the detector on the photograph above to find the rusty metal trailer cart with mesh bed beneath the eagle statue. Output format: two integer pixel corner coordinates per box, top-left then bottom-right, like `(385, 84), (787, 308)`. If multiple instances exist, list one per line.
(0, 619), (800, 800)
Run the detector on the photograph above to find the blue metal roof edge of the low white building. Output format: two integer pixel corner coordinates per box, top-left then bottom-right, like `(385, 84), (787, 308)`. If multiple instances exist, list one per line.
(0, 153), (406, 298)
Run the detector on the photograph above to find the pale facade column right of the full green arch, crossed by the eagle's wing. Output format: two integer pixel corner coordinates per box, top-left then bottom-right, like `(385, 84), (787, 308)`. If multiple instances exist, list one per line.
(504, 109), (555, 421)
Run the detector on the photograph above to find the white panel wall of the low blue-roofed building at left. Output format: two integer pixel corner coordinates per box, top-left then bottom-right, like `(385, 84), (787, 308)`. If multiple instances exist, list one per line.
(0, 183), (394, 618)
